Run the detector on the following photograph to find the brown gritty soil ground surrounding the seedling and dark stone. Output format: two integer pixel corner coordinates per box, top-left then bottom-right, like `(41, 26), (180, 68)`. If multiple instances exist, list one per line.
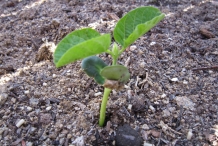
(0, 0), (218, 146)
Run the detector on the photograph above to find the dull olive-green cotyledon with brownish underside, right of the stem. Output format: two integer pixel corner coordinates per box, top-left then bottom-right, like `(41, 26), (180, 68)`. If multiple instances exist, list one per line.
(101, 65), (130, 83)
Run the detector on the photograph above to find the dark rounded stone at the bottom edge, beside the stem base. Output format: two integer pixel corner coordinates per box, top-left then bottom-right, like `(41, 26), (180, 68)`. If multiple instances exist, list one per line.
(115, 124), (143, 146)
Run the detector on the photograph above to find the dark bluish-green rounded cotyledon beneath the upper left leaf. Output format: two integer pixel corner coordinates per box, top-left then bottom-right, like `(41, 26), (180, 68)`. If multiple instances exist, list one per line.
(81, 56), (107, 85)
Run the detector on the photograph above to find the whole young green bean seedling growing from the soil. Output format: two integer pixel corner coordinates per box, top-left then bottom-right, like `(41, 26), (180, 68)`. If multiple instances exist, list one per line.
(54, 6), (164, 126)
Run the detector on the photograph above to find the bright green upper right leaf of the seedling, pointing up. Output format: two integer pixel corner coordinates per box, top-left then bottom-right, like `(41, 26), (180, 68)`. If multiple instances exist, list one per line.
(114, 6), (164, 48)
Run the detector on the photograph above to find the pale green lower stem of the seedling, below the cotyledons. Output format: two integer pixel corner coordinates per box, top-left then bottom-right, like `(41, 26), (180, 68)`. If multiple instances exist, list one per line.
(99, 88), (111, 127)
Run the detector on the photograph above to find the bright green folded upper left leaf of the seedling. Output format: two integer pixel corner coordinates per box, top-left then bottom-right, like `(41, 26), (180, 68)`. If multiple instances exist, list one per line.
(54, 28), (111, 67)
